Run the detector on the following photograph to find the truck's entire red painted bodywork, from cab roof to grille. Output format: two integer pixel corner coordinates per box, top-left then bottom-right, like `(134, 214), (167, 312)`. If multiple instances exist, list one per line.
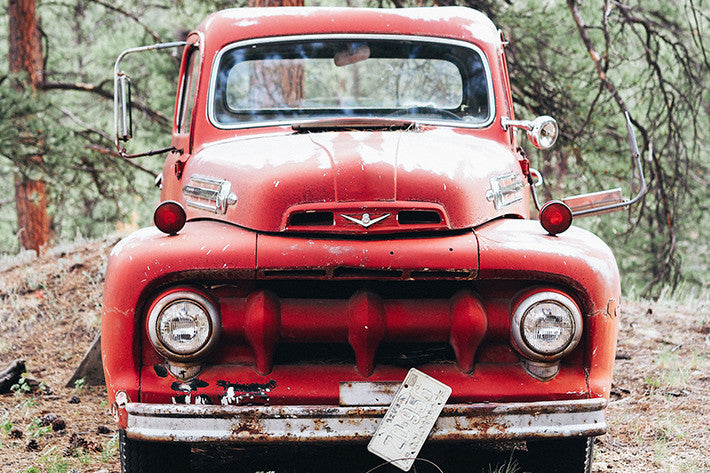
(102, 8), (620, 438)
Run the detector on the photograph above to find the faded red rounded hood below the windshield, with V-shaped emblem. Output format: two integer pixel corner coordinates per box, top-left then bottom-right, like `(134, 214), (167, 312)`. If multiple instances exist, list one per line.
(172, 128), (528, 233)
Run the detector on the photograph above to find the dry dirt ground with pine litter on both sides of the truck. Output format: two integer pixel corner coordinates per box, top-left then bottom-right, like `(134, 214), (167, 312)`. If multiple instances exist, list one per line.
(0, 238), (710, 473)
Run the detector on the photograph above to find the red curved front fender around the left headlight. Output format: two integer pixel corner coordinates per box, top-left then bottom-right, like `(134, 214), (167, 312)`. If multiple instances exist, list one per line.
(101, 220), (256, 402)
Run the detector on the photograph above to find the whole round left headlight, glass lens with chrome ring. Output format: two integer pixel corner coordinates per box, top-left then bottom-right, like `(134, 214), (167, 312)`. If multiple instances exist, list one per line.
(148, 290), (219, 361)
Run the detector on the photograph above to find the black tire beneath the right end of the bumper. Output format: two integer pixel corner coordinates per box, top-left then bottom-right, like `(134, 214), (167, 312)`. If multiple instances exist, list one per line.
(526, 437), (594, 473)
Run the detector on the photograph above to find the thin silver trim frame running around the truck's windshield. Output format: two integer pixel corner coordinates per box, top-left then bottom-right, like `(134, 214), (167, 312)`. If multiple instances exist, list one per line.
(207, 33), (496, 130)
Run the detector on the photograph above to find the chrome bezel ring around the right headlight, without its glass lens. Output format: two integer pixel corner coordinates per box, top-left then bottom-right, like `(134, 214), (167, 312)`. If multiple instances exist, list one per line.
(510, 289), (582, 361)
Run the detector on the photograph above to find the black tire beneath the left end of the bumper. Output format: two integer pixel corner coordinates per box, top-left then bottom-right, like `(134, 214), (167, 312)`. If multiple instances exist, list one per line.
(118, 430), (190, 473)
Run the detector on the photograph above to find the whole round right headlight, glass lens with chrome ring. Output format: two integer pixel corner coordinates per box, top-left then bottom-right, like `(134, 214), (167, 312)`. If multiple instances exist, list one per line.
(511, 291), (582, 361)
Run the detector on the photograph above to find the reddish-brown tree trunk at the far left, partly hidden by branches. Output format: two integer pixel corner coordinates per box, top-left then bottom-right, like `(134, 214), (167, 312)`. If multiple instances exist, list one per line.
(7, 0), (49, 254)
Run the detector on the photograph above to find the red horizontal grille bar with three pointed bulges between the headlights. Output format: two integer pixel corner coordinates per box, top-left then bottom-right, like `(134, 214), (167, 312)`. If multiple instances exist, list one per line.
(223, 289), (488, 377)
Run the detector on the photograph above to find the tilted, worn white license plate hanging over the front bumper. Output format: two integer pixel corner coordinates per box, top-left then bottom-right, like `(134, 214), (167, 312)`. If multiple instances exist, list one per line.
(367, 368), (451, 471)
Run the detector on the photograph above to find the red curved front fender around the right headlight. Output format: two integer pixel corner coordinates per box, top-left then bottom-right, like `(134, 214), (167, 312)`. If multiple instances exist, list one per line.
(476, 220), (621, 398)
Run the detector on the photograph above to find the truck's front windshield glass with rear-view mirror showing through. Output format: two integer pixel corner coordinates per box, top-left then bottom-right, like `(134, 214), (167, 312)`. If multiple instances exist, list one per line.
(210, 37), (493, 128)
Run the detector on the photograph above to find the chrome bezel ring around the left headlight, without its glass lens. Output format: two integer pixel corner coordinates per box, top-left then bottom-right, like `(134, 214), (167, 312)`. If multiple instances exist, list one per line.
(147, 288), (221, 362)
